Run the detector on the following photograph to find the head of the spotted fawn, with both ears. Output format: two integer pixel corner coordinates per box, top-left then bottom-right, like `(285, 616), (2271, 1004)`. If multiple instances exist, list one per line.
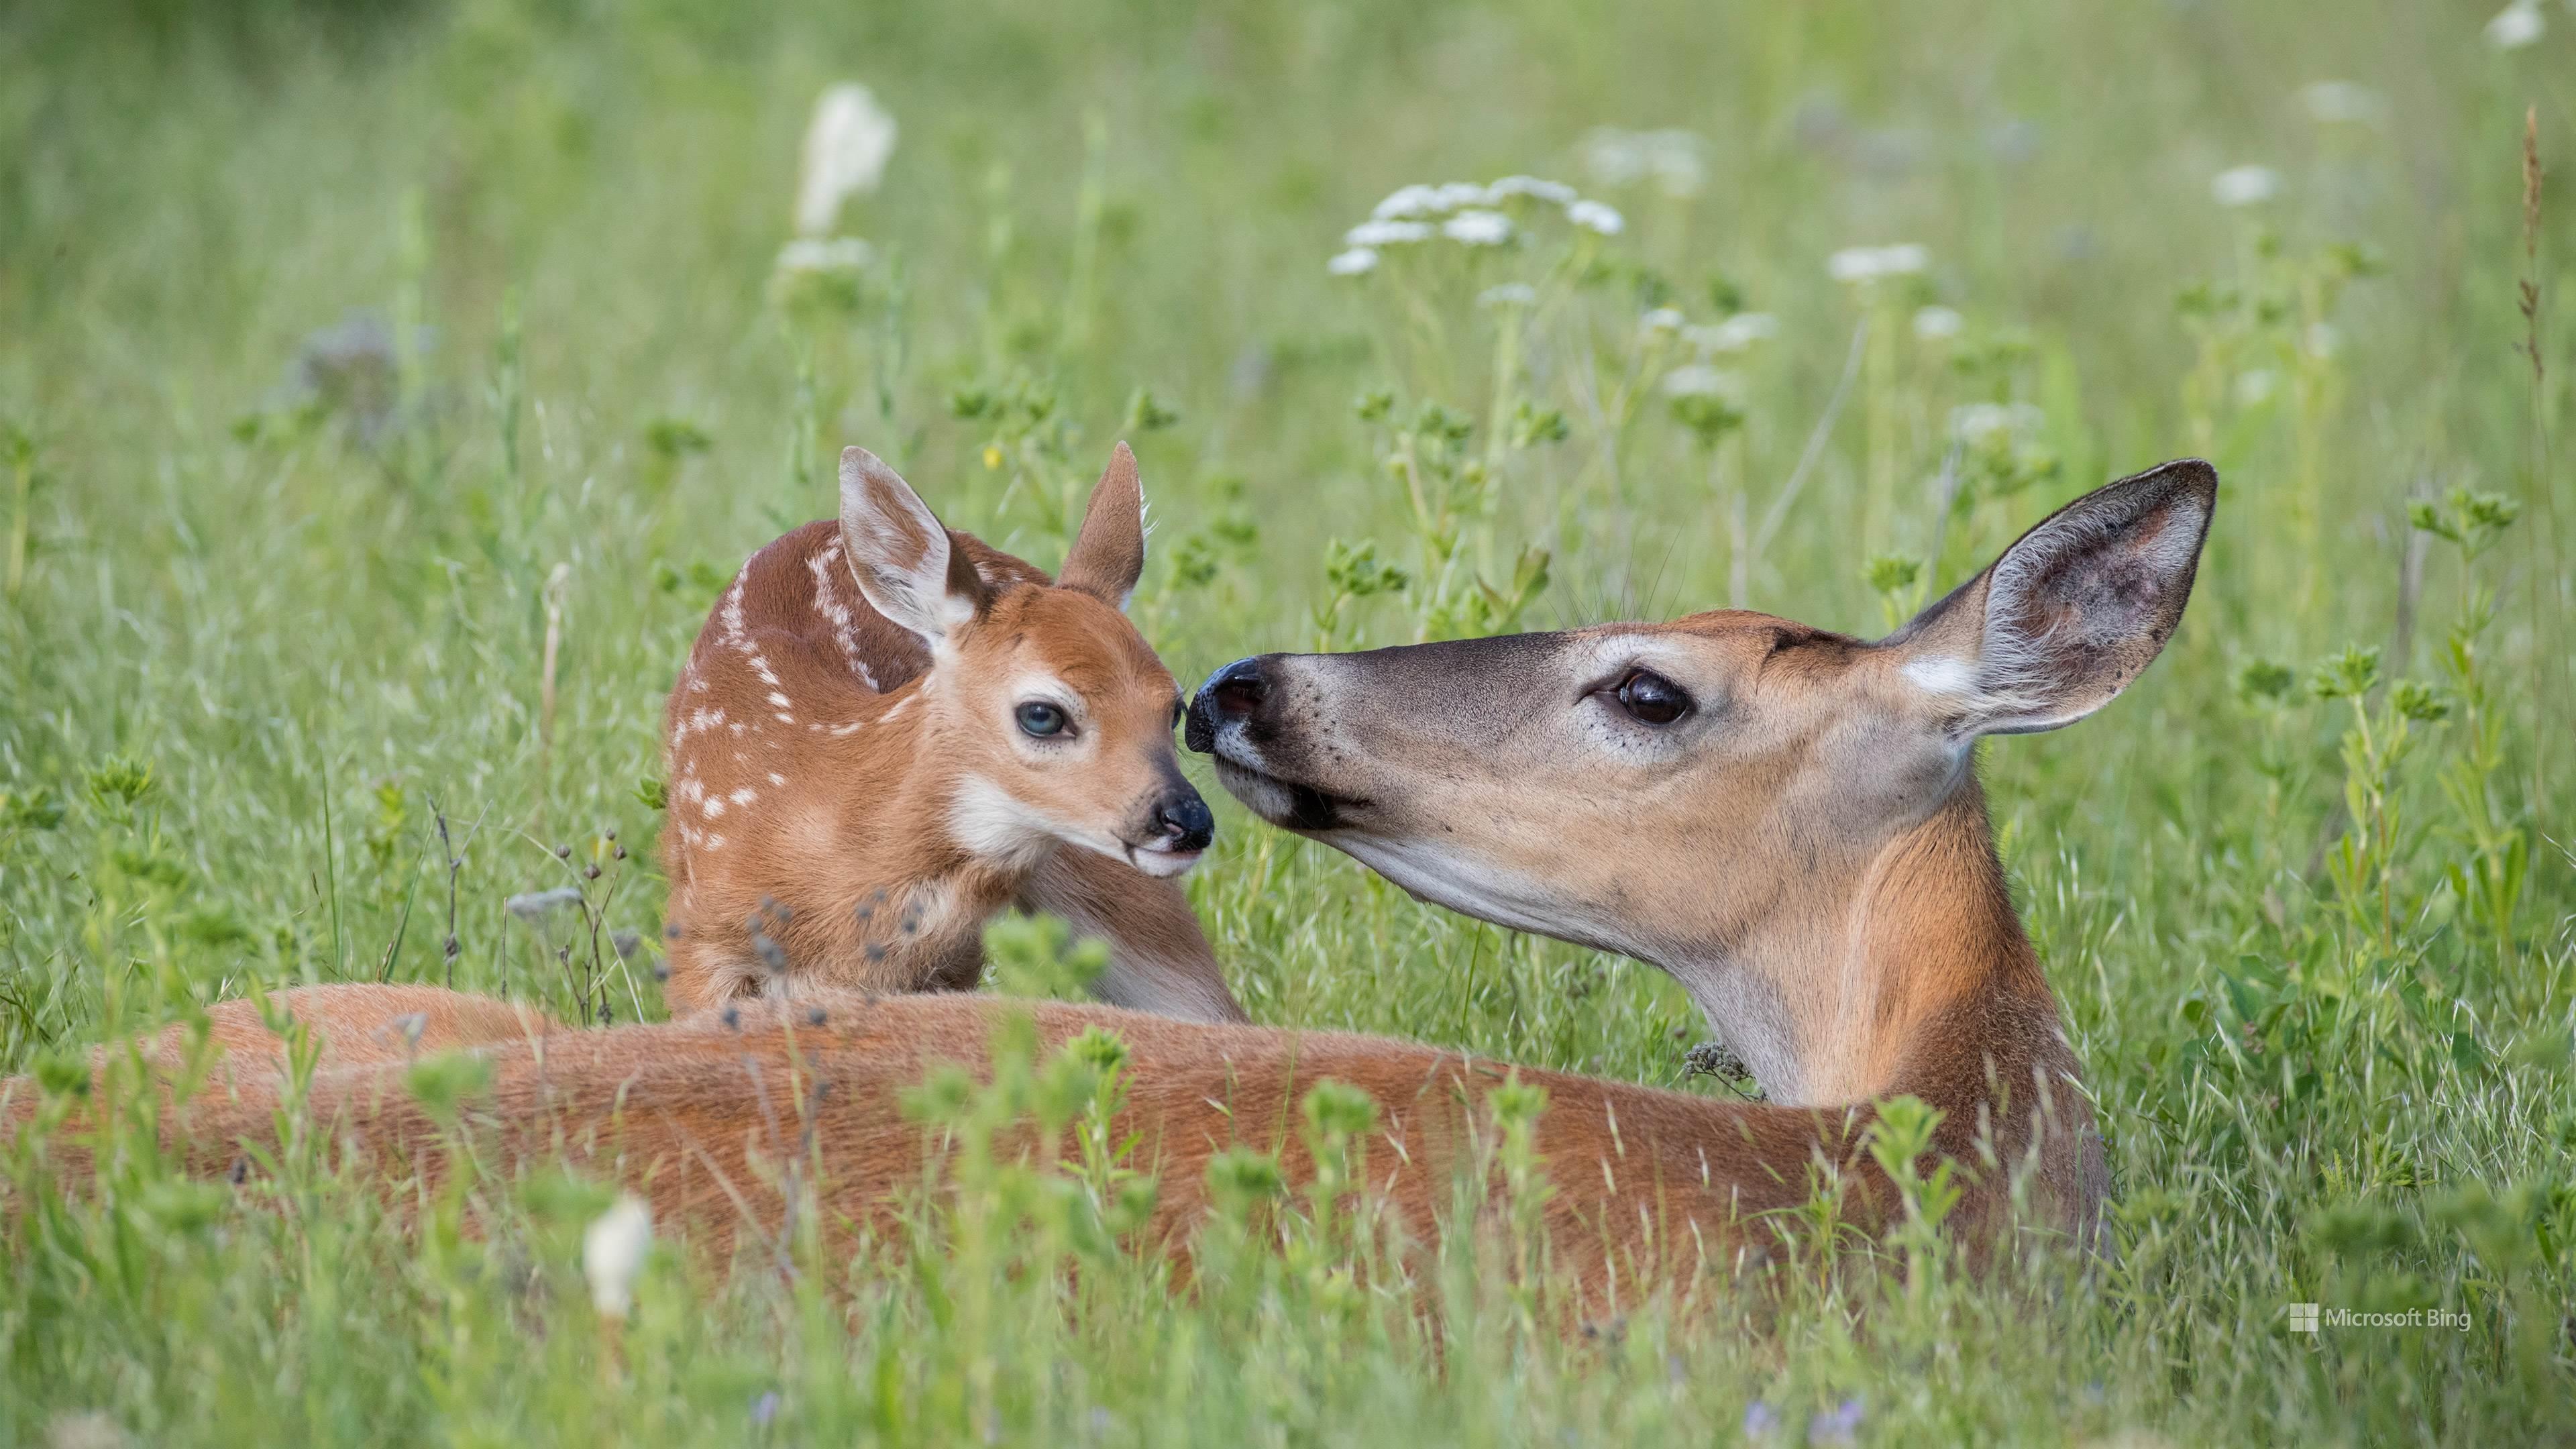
(840, 443), (1216, 877)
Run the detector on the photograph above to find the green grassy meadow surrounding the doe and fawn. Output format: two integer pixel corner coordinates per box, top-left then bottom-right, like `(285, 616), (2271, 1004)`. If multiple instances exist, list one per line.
(0, 0), (2576, 1446)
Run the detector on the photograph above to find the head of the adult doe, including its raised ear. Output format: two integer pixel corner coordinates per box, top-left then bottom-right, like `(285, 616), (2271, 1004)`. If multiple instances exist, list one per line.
(1190, 462), (2218, 1072)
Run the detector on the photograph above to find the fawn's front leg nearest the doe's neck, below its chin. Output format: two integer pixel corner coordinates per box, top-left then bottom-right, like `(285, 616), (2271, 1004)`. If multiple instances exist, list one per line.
(1020, 846), (1249, 1021)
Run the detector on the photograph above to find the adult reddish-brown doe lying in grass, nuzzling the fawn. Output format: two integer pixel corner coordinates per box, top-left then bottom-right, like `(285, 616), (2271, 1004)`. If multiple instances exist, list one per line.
(5, 462), (2218, 1309)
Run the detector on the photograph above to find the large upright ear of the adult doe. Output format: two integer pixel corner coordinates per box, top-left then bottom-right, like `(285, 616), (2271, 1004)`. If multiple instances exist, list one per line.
(1886, 459), (2218, 740)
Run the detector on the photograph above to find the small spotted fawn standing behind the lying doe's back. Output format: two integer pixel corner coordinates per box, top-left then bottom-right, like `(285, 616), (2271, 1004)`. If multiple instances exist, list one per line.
(662, 443), (1244, 1021)
